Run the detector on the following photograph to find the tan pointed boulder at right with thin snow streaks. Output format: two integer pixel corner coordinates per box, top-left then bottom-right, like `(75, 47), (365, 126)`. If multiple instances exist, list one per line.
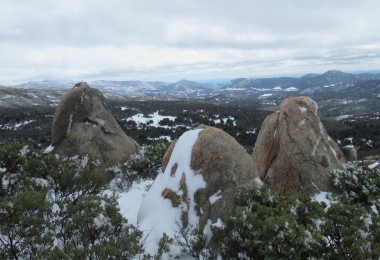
(253, 97), (345, 194)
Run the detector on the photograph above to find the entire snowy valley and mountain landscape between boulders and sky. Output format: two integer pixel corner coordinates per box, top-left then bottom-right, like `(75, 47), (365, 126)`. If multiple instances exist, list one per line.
(0, 70), (380, 158)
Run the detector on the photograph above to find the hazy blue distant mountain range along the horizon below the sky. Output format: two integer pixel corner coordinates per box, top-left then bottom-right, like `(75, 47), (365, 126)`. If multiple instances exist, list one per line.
(4, 70), (380, 116)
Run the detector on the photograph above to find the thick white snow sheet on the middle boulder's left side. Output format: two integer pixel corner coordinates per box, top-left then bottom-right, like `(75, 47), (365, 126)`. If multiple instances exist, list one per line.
(137, 129), (202, 254)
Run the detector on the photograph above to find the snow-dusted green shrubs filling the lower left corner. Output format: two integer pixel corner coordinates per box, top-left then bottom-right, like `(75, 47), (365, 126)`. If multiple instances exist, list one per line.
(0, 144), (143, 259)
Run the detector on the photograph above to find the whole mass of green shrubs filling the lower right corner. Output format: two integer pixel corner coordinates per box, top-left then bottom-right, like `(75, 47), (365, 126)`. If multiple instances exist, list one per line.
(213, 164), (380, 259)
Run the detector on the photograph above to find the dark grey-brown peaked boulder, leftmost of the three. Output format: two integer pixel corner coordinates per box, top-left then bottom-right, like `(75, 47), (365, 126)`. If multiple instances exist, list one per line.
(52, 82), (139, 165)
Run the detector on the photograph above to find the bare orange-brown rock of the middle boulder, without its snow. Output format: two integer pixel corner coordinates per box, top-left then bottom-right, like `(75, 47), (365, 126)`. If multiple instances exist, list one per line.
(163, 125), (261, 227)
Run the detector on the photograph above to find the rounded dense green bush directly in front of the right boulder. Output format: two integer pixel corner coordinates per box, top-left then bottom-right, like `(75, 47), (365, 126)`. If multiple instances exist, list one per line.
(214, 187), (326, 259)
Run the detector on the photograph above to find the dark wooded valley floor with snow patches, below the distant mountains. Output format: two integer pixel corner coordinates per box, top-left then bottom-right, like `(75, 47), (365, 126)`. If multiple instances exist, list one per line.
(0, 88), (380, 158)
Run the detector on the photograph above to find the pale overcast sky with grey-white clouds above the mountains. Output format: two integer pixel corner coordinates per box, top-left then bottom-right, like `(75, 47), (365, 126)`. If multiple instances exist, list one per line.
(0, 0), (380, 84)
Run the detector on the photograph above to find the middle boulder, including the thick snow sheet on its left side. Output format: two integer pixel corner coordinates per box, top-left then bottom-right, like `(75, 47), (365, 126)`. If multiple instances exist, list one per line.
(138, 125), (262, 252)
